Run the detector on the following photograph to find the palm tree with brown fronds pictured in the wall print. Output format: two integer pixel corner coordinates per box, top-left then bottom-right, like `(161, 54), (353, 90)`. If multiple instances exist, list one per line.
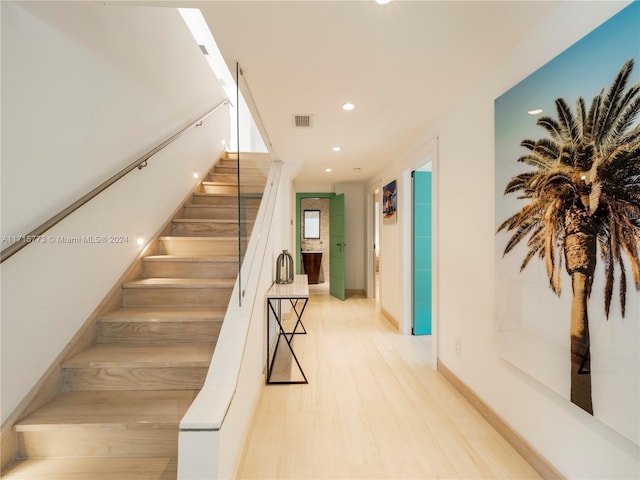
(498, 59), (640, 415)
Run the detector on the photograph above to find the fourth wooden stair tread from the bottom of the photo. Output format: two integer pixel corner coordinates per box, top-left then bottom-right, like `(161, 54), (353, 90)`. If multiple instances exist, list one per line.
(98, 307), (226, 323)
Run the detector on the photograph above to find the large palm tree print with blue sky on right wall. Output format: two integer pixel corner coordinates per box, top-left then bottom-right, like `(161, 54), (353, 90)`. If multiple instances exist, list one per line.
(495, 2), (640, 444)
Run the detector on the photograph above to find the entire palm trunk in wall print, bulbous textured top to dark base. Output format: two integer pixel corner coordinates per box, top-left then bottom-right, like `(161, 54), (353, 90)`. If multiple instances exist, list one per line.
(564, 206), (596, 415)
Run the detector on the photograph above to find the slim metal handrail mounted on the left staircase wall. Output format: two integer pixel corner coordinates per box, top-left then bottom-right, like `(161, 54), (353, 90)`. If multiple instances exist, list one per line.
(0, 98), (229, 263)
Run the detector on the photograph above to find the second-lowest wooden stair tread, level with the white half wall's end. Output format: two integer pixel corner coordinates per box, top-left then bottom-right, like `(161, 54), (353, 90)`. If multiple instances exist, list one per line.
(15, 390), (198, 432)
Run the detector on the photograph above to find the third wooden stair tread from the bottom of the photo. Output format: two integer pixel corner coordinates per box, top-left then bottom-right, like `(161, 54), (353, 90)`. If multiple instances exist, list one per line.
(62, 343), (214, 368)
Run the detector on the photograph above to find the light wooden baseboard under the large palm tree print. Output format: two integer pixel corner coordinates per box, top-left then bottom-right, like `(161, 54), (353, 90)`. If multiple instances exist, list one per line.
(437, 360), (565, 480)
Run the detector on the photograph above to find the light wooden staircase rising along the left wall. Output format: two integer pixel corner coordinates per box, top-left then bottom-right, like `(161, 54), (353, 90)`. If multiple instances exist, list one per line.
(2, 157), (266, 480)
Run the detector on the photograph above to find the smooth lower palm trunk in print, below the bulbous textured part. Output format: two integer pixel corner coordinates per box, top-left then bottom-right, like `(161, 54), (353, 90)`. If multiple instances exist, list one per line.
(571, 272), (593, 415)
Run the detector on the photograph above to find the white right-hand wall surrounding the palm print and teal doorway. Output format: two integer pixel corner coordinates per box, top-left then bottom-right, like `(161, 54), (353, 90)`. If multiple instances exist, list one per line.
(380, 2), (640, 479)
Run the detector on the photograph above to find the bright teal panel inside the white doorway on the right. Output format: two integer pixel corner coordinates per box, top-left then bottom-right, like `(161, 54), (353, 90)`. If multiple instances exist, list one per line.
(412, 172), (432, 335)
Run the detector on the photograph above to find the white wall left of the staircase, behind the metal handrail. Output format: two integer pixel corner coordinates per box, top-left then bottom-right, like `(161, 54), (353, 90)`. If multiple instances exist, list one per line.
(1, 2), (229, 422)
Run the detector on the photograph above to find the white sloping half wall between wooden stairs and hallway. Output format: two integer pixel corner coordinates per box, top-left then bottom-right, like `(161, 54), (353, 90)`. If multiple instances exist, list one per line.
(178, 161), (290, 480)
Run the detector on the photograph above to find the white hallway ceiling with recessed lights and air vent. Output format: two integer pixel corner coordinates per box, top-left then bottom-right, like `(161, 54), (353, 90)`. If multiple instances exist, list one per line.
(188, 0), (559, 184)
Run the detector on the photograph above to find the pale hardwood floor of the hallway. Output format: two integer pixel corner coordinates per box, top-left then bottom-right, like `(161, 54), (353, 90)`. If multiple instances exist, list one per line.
(237, 294), (541, 479)
